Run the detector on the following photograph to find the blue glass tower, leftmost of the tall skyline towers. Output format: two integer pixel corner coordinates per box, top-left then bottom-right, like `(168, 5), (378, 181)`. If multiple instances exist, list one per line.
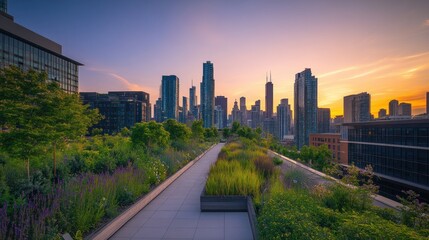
(161, 75), (179, 120)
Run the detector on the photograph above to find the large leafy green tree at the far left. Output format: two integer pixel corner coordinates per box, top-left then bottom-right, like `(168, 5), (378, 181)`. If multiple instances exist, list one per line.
(0, 67), (98, 180)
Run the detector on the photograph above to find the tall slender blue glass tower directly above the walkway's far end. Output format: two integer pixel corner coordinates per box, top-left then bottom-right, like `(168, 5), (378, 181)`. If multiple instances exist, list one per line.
(200, 61), (215, 128)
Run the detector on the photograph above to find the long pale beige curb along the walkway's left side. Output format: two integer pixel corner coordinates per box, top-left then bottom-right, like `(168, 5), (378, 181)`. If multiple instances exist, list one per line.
(91, 144), (217, 240)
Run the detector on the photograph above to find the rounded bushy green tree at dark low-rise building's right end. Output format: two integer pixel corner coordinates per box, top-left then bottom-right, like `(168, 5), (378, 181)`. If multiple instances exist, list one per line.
(131, 121), (170, 149)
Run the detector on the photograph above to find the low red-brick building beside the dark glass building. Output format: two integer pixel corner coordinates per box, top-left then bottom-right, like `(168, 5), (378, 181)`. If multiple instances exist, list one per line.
(310, 133), (340, 164)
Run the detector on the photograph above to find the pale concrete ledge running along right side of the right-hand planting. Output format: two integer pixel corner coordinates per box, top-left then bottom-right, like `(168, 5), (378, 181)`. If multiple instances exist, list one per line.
(268, 150), (403, 211)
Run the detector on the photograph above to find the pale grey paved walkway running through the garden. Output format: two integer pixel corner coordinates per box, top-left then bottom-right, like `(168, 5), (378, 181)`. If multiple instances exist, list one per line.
(110, 144), (253, 240)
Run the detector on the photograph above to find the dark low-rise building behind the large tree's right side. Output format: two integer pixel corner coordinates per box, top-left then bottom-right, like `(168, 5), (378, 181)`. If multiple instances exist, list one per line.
(80, 91), (151, 134)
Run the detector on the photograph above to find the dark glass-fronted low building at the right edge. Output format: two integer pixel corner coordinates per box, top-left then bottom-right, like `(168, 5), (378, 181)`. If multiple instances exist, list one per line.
(344, 119), (429, 201)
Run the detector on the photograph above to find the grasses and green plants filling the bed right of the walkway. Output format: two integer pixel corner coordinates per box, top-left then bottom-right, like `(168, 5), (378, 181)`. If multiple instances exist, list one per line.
(206, 138), (429, 239)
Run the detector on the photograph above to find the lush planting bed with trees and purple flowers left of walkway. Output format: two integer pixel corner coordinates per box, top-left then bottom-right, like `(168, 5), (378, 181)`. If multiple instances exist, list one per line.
(0, 68), (218, 239)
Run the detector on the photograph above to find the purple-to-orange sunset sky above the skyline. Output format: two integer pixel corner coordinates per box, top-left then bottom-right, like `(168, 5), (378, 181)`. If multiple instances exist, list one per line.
(8, 0), (429, 116)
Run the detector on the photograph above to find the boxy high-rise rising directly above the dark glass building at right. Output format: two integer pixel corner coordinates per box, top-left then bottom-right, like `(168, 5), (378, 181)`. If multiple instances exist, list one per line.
(344, 92), (371, 123)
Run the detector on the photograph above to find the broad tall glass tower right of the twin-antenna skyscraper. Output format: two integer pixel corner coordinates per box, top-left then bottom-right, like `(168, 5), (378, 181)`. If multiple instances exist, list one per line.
(294, 68), (317, 149)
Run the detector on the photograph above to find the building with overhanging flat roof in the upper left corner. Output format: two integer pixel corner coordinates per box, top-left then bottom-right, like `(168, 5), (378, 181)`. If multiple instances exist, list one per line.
(0, 4), (82, 93)
